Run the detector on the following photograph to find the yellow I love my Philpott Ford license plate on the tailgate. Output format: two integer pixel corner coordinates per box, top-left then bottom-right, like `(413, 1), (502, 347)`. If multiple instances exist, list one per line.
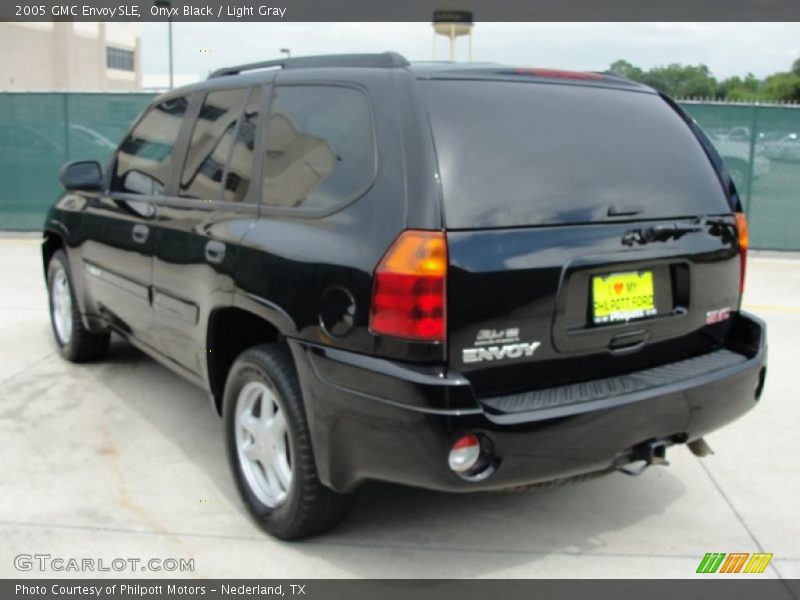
(592, 271), (656, 323)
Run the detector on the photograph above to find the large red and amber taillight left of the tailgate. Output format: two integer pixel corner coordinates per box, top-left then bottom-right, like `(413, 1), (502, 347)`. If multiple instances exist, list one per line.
(369, 230), (447, 342)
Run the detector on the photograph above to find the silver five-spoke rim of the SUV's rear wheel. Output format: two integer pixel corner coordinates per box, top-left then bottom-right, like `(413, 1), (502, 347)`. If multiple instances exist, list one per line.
(235, 381), (293, 508)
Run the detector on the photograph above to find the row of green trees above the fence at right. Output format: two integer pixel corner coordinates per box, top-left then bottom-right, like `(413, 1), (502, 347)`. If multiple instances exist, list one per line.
(610, 58), (800, 102)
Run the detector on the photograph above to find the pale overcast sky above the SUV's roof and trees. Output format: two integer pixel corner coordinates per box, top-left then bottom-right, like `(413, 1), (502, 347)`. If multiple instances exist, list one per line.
(142, 22), (800, 86)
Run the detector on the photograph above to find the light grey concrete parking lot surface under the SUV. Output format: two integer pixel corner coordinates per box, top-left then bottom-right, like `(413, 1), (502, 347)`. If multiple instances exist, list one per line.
(0, 236), (800, 578)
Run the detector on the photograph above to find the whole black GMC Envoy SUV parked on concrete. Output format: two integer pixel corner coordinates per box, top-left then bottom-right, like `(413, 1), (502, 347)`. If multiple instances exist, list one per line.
(43, 53), (766, 538)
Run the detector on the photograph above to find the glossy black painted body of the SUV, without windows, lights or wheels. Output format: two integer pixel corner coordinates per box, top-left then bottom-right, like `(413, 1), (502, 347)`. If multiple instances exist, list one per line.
(44, 59), (766, 491)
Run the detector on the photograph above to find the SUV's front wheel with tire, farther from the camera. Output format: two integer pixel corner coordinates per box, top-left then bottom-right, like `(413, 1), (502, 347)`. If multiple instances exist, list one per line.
(47, 250), (111, 363)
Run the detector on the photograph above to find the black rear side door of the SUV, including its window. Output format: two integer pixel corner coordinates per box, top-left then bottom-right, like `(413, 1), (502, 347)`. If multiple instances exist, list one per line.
(148, 85), (269, 378)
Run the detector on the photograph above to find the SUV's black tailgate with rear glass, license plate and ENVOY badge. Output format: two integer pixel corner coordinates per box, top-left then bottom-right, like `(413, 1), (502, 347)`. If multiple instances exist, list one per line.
(420, 80), (739, 397)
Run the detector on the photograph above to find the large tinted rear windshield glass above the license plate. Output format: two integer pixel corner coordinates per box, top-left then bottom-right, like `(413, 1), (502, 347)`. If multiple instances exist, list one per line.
(420, 80), (730, 229)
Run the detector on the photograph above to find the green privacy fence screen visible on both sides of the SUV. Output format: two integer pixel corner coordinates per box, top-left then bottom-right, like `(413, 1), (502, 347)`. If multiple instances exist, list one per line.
(0, 92), (800, 250)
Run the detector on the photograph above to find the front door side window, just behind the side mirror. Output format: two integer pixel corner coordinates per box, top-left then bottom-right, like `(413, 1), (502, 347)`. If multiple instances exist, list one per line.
(111, 97), (188, 196)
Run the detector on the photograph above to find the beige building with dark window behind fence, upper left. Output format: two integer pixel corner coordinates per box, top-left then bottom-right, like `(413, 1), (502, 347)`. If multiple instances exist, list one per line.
(0, 22), (142, 91)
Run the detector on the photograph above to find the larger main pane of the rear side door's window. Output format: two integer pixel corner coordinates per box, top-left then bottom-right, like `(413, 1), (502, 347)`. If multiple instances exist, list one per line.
(179, 88), (249, 200)
